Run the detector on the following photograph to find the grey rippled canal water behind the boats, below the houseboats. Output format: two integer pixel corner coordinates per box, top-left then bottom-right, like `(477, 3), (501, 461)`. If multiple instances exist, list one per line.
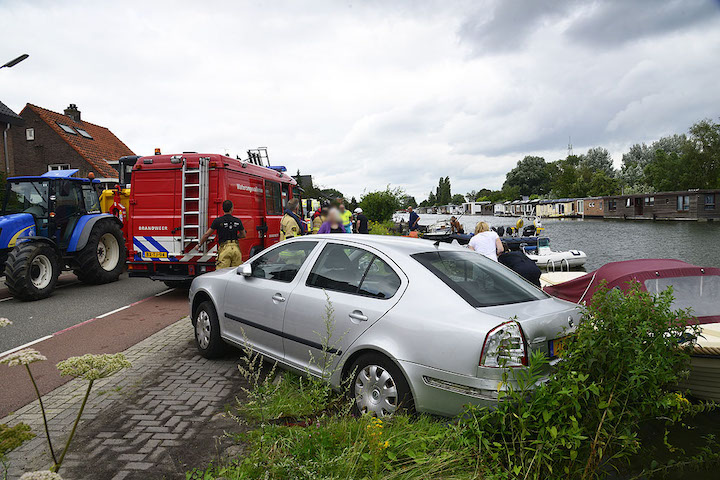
(400, 214), (720, 271)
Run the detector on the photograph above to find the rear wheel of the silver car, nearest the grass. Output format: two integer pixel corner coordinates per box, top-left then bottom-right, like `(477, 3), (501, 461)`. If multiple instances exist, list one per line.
(348, 353), (415, 417)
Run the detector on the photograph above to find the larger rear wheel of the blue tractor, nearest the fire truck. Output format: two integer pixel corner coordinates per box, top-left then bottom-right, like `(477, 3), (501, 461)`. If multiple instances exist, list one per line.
(73, 220), (126, 285)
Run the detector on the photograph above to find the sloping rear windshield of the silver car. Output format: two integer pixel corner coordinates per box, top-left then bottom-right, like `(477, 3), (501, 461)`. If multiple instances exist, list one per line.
(412, 251), (548, 308)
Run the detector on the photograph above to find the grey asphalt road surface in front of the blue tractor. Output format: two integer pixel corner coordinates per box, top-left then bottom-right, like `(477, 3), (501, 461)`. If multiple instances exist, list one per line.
(0, 273), (172, 353)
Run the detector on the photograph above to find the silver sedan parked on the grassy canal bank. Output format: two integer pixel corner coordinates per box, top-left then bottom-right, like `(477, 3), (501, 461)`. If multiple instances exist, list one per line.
(190, 234), (580, 416)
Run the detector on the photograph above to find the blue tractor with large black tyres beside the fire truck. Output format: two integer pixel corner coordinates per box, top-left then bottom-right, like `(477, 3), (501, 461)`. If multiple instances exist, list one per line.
(0, 169), (126, 300)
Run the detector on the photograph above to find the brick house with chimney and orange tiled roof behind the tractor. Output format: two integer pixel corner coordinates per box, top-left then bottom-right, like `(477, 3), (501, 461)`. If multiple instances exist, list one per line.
(9, 103), (134, 178)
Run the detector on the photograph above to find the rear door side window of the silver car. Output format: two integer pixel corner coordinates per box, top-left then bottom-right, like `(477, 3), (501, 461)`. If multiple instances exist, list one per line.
(307, 243), (400, 298)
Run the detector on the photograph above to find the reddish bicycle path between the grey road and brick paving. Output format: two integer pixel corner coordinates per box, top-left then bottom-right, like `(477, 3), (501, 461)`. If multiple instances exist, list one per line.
(0, 290), (189, 418)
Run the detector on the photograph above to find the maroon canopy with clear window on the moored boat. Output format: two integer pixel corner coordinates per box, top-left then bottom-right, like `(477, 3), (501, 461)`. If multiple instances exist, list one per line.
(544, 259), (720, 323)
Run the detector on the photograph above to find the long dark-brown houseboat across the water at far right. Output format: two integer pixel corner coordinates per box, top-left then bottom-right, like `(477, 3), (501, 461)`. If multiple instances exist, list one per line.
(603, 190), (720, 220)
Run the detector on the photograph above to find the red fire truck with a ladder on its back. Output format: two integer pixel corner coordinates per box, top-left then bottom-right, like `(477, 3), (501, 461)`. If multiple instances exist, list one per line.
(126, 149), (297, 286)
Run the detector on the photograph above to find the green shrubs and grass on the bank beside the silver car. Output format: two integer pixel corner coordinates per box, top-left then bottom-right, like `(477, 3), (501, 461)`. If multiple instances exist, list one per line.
(188, 283), (720, 480)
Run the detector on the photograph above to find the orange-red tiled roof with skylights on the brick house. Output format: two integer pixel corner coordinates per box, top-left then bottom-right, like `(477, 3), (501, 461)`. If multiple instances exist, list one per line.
(20, 103), (134, 178)
